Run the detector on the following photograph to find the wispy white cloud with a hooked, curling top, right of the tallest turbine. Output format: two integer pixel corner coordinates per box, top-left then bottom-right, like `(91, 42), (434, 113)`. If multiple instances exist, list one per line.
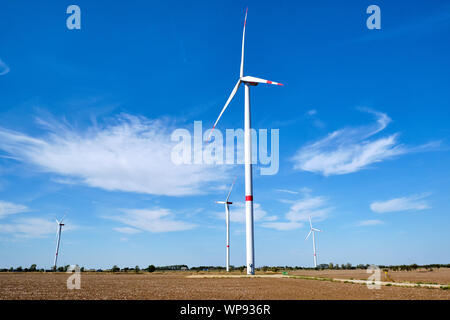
(292, 109), (440, 176)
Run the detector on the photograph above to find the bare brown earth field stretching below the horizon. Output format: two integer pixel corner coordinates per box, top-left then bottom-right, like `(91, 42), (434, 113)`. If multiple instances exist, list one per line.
(0, 270), (450, 300)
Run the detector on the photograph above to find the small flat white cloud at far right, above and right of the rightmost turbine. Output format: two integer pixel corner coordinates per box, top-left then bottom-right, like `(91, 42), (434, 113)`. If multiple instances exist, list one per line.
(370, 193), (431, 213)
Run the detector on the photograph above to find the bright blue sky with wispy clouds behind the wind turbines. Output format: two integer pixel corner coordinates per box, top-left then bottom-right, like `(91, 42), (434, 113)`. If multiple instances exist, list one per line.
(0, 1), (450, 267)
